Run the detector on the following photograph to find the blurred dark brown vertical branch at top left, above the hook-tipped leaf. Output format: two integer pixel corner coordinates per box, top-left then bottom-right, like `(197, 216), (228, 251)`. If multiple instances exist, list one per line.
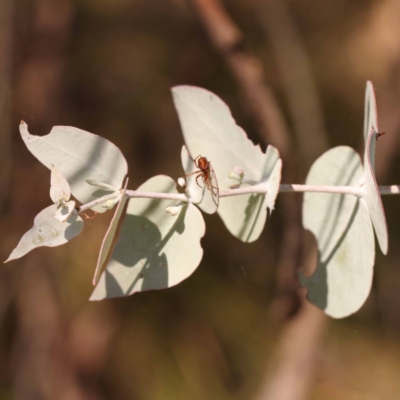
(14, 0), (73, 129)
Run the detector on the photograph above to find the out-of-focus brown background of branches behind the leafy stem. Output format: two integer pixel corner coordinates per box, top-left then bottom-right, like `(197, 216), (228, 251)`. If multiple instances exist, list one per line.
(0, 0), (400, 400)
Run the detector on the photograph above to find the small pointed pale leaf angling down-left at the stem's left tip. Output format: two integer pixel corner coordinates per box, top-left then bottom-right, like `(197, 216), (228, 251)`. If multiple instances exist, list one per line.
(5, 204), (83, 262)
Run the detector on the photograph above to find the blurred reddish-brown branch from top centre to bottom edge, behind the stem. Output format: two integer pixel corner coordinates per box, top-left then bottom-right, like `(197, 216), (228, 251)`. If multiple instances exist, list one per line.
(186, 0), (325, 400)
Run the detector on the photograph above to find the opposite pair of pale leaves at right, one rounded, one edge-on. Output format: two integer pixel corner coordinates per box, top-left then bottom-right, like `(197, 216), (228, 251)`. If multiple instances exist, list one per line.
(300, 82), (388, 318)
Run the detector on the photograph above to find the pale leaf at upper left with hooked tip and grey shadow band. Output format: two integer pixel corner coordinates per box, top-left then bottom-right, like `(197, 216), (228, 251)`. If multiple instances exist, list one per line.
(20, 122), (128, 212)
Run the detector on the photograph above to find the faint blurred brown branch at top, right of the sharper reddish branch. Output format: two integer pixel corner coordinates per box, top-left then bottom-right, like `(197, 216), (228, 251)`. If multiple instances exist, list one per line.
(254, 0), (328, 170)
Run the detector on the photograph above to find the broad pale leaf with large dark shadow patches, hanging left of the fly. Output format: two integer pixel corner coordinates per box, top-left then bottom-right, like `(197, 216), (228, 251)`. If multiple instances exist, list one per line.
(90, 175), (205, 300)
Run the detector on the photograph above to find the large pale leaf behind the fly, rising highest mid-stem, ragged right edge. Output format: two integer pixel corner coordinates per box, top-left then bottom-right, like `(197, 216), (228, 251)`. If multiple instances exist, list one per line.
(172, 86), (281, 242)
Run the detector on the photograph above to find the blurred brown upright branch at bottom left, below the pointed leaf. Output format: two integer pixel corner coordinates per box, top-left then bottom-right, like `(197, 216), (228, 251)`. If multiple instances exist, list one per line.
(13, 255), (86, 400)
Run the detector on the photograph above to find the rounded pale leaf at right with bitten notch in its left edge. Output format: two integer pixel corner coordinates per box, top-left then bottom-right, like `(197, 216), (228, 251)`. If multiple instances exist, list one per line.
(300, 146), (375, 318)
